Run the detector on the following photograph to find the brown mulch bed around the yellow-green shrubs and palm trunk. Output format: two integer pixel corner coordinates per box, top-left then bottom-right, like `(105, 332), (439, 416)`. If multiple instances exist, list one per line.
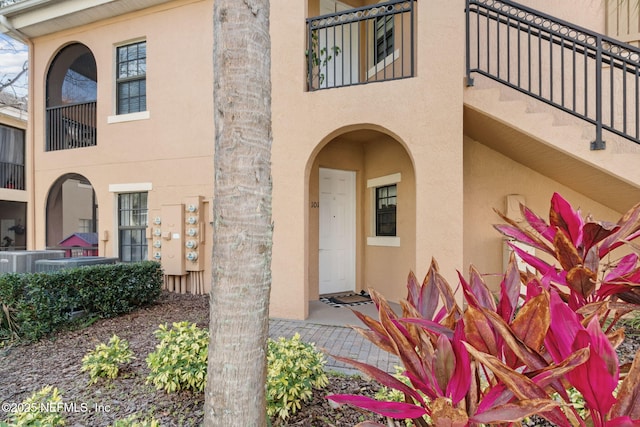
(0, 293), (378, 427)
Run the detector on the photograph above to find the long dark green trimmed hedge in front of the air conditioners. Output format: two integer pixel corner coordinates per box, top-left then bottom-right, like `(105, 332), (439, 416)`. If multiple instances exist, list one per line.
(0, 261), (163, 340)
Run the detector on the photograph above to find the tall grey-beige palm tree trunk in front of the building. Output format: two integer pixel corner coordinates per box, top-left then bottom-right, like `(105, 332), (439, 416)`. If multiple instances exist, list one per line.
(204, 0), (273, 427)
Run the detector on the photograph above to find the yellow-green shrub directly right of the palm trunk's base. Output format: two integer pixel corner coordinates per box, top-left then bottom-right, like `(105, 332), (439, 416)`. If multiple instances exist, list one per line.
(267, 333), (329, 420)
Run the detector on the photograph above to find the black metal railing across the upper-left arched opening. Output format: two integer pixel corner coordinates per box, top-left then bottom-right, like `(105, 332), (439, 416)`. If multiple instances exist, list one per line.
(46, 102), (96, 151)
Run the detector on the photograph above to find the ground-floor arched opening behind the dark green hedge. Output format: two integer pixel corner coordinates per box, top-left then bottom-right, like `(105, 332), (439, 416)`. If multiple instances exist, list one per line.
(46, 174), (98, 255)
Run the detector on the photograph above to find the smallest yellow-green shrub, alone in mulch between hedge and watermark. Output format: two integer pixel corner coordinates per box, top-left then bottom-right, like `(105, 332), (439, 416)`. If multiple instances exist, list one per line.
(82, 334), (134, 384)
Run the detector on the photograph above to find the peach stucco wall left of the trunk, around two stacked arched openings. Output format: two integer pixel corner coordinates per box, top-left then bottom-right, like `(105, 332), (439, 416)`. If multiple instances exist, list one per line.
(30, 0), (213, 268)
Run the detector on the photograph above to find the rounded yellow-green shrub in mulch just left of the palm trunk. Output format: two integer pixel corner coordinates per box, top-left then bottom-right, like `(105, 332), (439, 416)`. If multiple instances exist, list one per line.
(147, 322), (209, 393)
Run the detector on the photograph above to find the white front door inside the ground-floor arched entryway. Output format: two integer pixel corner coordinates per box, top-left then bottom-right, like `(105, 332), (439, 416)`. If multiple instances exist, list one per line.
(318, 168), (356, 294)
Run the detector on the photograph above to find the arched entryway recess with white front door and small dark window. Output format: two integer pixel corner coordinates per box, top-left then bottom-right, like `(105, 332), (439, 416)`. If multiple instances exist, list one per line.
(308, 129), (416, 300)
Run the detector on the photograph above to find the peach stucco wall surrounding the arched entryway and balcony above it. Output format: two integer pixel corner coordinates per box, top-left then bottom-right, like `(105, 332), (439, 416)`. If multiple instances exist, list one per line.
(271, 0), (464, 318)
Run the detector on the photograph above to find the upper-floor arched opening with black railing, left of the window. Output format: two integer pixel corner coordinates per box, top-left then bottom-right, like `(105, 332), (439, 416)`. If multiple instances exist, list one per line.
(46, 43), (98, 151)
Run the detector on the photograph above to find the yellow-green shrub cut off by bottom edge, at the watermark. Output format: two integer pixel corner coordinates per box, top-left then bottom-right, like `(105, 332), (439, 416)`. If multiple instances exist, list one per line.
(8, 386), (64, 427)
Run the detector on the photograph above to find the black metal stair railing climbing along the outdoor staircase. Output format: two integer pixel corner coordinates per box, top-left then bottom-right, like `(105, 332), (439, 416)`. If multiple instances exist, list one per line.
(466, 0), (640, 149)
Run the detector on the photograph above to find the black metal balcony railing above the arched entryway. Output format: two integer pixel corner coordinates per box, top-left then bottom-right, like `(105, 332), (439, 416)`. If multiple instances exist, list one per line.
(306, 0), (415, 91)
